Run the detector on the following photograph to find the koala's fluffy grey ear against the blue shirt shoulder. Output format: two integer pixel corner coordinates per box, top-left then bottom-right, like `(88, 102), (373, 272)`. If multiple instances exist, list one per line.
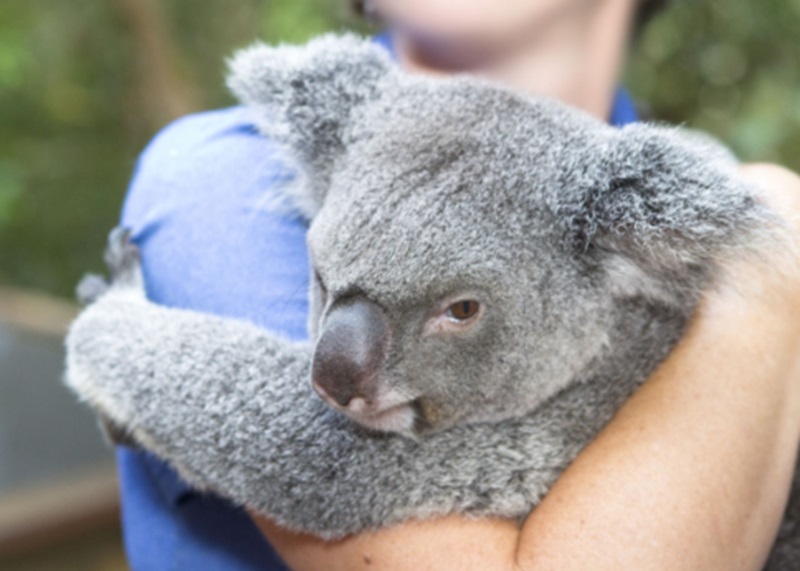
(228, 34), (396, 217)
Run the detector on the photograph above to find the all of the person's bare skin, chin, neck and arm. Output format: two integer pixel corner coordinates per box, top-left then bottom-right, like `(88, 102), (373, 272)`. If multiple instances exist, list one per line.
(247, 0), (800, 571)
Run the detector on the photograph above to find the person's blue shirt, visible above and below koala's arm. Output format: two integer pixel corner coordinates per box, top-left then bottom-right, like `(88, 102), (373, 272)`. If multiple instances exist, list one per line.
(117, 42), (636, 571)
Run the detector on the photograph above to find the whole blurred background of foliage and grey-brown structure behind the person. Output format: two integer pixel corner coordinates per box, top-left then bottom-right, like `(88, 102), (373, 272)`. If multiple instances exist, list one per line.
(0, 0), (800, 571)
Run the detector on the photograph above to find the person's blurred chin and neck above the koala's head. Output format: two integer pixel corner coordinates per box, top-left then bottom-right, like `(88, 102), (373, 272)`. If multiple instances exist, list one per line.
(384, 0), (635, 119)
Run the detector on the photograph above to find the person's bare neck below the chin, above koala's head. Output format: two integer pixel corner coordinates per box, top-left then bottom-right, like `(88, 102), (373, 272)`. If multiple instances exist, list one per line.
(392, 1), (631, 120)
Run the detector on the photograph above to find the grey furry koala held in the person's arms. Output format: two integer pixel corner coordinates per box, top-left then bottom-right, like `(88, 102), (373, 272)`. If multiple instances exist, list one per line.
(66, 35), (800, 568)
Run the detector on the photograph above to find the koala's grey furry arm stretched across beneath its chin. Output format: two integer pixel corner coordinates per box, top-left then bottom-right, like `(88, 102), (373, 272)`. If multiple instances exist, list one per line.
(66, 232), (578, 539)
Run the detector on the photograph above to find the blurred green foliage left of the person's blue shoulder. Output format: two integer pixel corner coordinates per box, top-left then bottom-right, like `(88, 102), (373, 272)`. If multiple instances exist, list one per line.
(0, 0), (360, 297)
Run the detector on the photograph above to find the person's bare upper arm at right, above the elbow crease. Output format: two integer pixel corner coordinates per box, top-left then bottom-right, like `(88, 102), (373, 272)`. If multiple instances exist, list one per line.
(517, 286), (800, 569)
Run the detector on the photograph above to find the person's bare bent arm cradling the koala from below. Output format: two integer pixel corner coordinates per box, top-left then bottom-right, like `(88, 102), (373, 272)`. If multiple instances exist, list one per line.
(247, 165), (800, 570)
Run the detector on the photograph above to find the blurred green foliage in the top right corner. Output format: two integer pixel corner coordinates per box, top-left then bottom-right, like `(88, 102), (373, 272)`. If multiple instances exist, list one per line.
(627, 0), (800, 170)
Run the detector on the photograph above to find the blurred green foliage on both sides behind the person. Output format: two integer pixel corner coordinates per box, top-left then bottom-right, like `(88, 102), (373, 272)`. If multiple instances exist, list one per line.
(0, 0), (800, 296)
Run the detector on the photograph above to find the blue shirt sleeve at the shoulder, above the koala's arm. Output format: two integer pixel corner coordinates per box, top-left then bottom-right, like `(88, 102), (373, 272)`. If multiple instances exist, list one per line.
(122, 107), (309, 339)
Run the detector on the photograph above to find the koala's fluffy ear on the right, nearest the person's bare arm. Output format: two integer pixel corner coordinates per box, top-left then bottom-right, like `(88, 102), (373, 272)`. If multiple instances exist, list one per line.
(561, 124), (777, 298)
